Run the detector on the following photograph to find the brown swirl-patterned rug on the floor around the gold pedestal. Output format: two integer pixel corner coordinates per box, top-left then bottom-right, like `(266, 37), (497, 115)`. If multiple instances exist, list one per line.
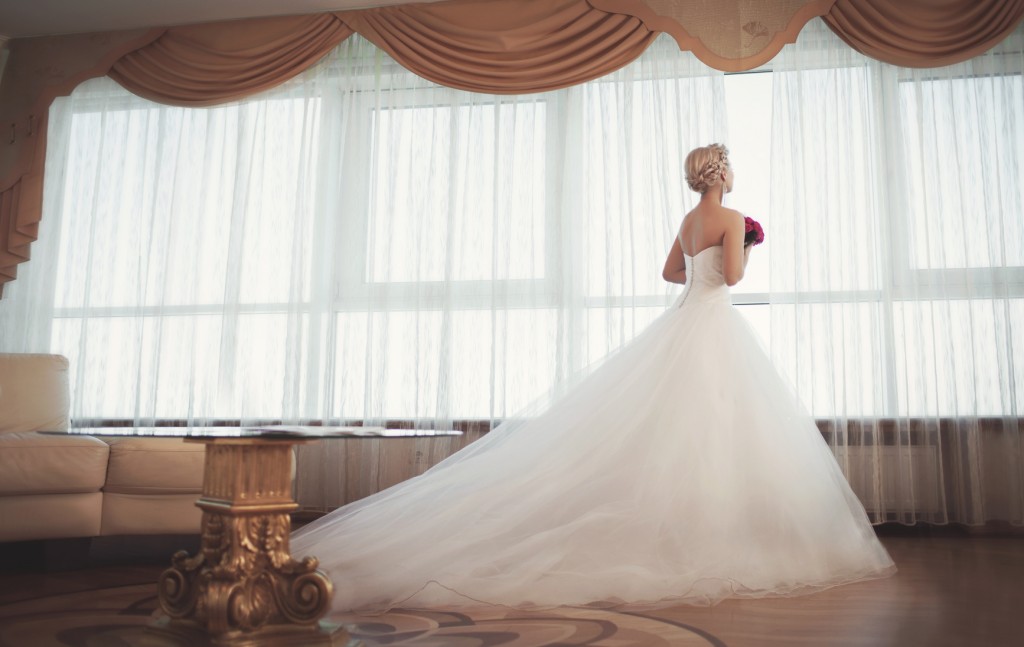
(0, 585), (724, 647)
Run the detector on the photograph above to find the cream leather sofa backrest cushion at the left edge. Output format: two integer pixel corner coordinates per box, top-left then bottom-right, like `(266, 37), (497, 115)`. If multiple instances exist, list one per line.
(0, 353), (70, 434)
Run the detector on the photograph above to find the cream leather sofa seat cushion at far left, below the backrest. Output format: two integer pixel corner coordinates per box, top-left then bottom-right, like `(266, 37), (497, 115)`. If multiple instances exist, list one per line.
(0, 432), (110, 497)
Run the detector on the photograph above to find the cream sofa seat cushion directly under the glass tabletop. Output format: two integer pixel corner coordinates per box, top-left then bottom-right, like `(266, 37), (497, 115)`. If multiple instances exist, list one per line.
(103, 437), (206, 499)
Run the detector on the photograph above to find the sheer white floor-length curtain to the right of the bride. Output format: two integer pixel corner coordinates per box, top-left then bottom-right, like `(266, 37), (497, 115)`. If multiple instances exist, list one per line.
(769, 20), (1024, 524)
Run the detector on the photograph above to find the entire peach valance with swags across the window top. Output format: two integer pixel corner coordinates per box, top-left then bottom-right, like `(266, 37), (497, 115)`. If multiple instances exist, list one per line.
(0, 0), (1024, 297)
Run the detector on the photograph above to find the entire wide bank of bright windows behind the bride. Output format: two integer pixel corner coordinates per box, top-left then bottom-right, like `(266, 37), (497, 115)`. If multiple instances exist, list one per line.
(44, 37), (1024, 421)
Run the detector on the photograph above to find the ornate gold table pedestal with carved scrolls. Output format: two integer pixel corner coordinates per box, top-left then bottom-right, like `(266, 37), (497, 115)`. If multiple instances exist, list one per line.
(144, 437), (350, 647)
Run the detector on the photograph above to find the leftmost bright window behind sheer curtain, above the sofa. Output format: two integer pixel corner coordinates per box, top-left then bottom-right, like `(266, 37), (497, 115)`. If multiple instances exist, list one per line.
(47, 94), (319, 419)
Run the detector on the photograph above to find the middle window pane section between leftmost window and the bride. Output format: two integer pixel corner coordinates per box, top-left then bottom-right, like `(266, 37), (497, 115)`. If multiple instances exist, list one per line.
(330, 87), (558, 419)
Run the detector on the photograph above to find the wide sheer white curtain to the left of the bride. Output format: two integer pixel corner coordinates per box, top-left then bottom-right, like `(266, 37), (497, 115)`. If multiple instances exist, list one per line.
(0, 37), (725, 507)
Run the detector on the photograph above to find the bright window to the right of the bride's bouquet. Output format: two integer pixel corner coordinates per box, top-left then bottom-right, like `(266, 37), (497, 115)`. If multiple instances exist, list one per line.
(768, 59), (1024, 418)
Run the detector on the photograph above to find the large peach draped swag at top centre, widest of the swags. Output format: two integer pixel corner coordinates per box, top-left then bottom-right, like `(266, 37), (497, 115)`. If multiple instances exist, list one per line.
(337, 0), (657, 94)
